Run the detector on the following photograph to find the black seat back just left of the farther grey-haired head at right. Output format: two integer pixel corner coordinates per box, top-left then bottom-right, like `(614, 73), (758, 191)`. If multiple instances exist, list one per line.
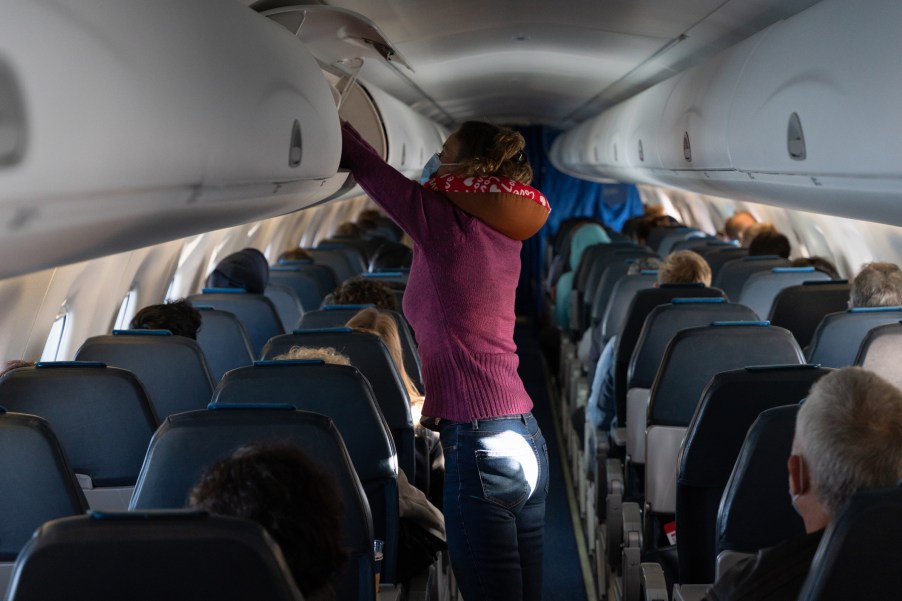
(768, 280), (849, 348)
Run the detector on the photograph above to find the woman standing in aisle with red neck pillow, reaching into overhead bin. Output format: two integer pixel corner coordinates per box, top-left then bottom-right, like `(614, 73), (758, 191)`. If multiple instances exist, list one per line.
(341, 121), (549, 601)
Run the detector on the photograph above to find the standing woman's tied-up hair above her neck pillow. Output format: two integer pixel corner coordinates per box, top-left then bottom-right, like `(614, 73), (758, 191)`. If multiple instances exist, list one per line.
(454, 121), (532, 184)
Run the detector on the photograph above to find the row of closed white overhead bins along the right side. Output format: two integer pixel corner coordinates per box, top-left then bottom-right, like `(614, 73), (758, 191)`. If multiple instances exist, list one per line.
(552, 0), (902, 225)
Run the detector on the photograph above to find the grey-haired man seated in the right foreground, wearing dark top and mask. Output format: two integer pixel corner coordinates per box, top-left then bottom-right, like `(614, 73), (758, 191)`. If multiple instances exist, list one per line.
(705, 367), (902, 601)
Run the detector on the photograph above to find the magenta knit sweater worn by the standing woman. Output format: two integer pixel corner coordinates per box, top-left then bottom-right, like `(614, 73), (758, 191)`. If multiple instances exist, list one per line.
(341, 125), (532, 421)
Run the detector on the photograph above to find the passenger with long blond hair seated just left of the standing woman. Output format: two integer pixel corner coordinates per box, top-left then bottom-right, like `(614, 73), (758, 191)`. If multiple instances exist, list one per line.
(346, 309), (445, 508)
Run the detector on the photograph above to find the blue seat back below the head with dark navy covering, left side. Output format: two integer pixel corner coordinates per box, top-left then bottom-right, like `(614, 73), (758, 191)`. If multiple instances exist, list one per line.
(187, 288), (285, 357)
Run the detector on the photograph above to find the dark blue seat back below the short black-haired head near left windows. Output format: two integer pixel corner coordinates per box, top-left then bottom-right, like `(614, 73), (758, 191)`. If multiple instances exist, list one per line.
(75, 330), (213, 421)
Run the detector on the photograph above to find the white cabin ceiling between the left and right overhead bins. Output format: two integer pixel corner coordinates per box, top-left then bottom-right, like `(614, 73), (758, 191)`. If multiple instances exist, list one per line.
(251, 0), (817, 127)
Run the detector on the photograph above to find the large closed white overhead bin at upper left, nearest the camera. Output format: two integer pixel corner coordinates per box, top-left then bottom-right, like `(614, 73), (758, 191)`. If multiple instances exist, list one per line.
(0, 0), (343, 277)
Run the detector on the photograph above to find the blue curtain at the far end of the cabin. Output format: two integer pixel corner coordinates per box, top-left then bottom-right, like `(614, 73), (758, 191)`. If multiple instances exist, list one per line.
(516, 126), (642, 317)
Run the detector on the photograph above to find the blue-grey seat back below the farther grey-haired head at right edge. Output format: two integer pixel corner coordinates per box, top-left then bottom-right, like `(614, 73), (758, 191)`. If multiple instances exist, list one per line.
(808, 307), (902, 367)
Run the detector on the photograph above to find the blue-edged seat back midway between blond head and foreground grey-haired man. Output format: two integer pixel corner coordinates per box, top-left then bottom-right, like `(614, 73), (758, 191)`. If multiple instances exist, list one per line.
(648, 322), (803, 426)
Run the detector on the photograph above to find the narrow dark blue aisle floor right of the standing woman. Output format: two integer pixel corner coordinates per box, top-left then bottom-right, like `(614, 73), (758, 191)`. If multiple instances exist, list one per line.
(515, 328), (586, 601)
